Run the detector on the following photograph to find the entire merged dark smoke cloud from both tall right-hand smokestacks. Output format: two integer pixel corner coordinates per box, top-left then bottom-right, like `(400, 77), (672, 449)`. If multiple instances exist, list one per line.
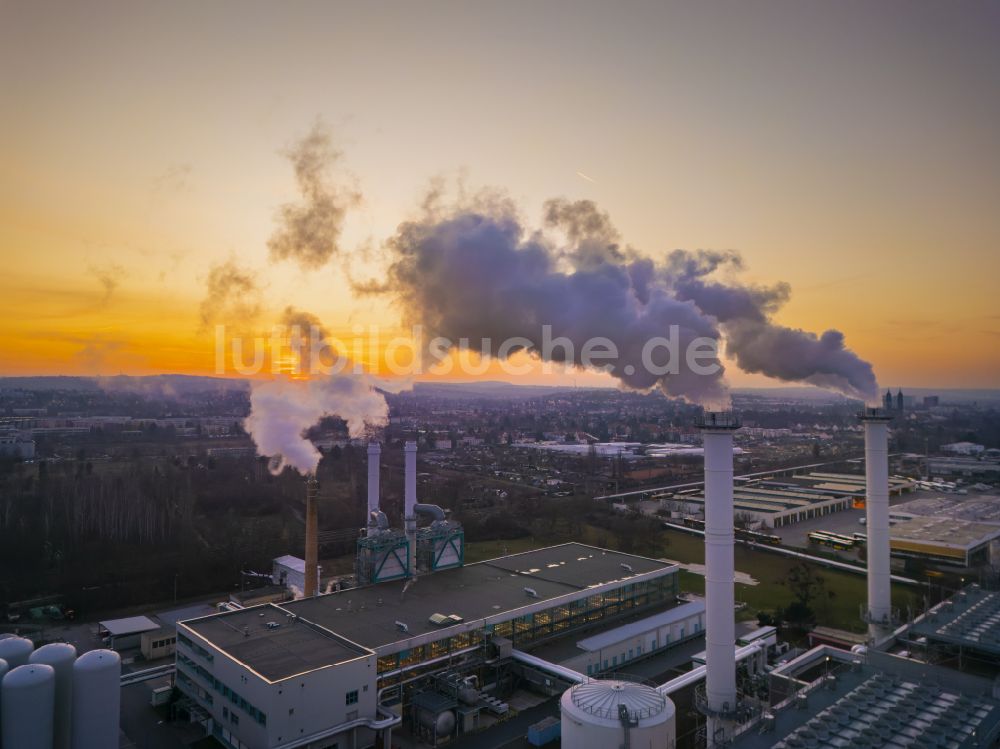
(371, 193), (877, 403)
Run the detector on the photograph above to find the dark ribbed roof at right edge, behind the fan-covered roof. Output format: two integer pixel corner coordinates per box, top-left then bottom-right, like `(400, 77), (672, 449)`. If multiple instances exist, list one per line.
(910, 585), (1000, 656)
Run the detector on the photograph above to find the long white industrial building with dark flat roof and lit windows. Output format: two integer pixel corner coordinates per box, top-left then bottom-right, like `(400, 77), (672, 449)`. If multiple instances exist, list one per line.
(177, 543), (678, 749)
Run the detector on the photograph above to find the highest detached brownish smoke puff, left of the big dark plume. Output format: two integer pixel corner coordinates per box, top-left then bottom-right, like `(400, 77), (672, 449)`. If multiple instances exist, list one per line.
(267, 123), (361, 269)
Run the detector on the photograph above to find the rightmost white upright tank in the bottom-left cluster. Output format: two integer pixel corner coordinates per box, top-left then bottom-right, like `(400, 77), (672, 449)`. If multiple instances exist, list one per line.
(70, 650), (122, 749)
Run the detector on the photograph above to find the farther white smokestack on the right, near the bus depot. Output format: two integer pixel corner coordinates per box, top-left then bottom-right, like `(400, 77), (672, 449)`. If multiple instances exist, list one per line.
(858, 408), (892, 642)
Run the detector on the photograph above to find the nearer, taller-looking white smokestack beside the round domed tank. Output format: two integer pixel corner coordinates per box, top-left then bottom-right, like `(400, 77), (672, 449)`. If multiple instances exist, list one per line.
(698, 411), (740, 747)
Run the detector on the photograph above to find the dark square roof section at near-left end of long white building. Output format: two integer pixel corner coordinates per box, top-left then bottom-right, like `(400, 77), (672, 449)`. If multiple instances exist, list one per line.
(184, 604), (371, 681)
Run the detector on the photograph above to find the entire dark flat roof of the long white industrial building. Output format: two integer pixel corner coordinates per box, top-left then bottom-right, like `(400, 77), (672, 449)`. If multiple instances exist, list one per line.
(185, 543), (676, 678)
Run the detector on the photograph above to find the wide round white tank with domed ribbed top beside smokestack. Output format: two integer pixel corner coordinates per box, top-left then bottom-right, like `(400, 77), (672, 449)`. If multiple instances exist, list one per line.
(559, 679), (677, 749)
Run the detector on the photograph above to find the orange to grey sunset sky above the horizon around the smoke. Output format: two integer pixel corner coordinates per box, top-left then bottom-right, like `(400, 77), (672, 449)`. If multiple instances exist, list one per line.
(0, 2), (1000, 388)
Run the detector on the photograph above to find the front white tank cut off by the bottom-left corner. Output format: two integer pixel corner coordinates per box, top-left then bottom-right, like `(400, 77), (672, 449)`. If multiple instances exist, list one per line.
(0, 663), (55, 749)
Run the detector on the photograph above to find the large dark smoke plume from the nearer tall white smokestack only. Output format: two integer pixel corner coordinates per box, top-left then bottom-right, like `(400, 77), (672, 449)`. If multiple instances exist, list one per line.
(389, 194), (725, 401)
